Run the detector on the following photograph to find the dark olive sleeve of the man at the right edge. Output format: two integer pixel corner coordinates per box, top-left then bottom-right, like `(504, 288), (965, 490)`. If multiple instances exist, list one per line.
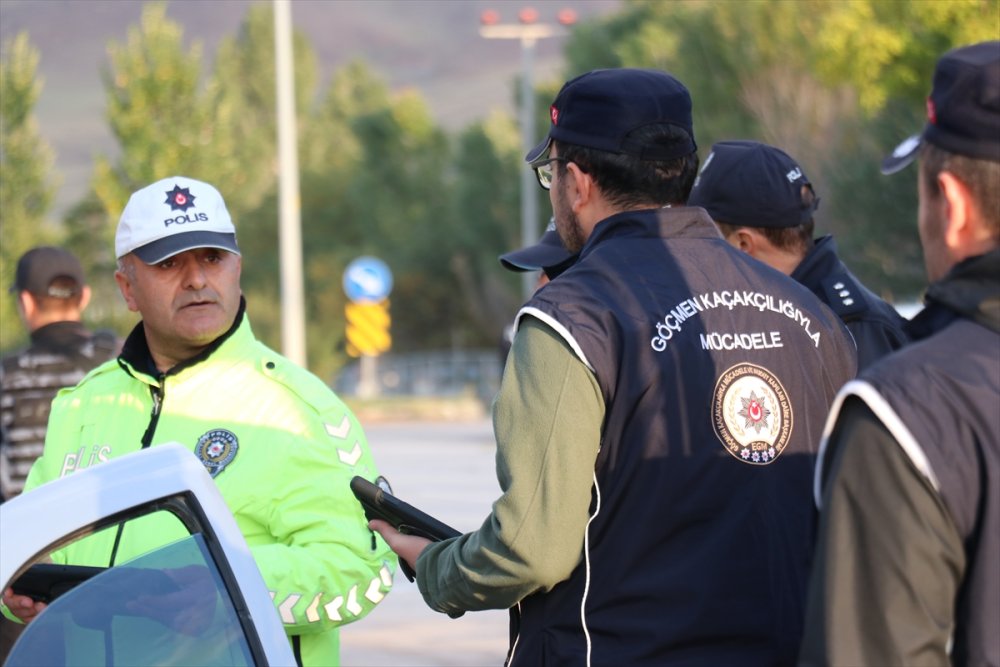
(799, 398), (965, 667)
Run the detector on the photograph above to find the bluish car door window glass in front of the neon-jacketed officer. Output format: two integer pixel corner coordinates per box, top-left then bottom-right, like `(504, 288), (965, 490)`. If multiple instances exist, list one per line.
(6, 527), (253, 666)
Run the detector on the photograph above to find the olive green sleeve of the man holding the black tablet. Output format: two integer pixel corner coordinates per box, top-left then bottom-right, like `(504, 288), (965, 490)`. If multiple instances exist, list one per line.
(416, 318), (604, 614)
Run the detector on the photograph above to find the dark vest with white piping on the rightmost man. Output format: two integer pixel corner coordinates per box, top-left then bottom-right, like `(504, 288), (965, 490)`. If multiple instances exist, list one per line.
(861, 288), (1000, 665)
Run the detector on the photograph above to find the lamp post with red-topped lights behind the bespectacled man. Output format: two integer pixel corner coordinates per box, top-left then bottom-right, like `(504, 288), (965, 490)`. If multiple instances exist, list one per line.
(479, 7), (576, 301)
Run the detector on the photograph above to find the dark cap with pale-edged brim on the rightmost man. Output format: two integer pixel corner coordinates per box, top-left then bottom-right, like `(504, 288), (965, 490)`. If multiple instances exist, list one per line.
(882, 41), (1000, 174)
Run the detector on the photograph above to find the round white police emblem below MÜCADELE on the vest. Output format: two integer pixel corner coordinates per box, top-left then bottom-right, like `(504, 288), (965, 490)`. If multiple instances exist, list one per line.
(712, 363), (792, 465)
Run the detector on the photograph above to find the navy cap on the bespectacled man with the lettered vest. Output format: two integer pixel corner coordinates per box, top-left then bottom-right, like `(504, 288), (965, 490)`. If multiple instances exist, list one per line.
(524, 68), (698, 162)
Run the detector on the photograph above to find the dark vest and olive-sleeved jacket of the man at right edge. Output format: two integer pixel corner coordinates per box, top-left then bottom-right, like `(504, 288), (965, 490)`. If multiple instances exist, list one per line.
(802, 250), (1000, 666)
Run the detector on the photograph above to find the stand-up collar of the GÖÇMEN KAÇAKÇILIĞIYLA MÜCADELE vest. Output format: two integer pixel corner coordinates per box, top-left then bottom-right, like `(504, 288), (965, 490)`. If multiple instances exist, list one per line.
(580, 206), (722, 258)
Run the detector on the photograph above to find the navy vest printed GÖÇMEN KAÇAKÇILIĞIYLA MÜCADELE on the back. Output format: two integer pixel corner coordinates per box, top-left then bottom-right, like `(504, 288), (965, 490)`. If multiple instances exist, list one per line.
(510, 208), (856, 667)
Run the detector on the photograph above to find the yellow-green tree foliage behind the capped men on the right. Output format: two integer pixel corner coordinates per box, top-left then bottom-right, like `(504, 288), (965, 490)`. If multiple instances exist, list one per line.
(566, 0), (988, 296)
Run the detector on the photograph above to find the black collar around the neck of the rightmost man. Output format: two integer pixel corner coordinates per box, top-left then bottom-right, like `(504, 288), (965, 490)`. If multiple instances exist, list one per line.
(907, 248), (1000, 339)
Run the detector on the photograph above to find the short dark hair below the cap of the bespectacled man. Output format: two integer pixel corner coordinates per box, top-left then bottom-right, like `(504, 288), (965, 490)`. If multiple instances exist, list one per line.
(553, 123), (698, 209)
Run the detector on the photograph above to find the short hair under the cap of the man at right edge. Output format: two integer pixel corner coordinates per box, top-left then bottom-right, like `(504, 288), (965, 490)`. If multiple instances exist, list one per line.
(920, 141), (1000, 241)
